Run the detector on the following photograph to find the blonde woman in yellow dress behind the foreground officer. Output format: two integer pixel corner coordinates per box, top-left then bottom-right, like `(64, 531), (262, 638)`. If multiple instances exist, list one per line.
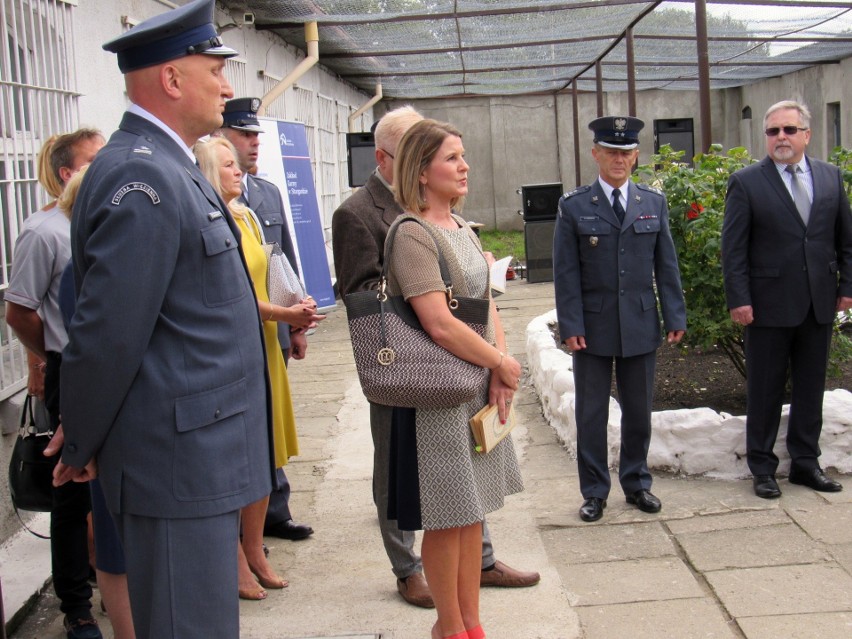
(194, 137), (325, 600)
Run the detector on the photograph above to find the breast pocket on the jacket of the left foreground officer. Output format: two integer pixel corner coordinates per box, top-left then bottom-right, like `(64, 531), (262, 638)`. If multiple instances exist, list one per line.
(201, 220), (248, 306)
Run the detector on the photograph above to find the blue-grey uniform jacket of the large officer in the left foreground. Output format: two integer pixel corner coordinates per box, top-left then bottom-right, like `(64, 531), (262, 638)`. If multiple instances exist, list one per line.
(61, 113), (273, 518)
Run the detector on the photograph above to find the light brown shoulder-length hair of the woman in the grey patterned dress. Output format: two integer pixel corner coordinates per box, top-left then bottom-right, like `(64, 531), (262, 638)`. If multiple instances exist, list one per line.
(393, 119), (462, 214)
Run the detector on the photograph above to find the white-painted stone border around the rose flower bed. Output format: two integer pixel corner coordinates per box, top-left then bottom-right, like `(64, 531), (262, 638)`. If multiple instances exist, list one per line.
(527, 310), (852, 479)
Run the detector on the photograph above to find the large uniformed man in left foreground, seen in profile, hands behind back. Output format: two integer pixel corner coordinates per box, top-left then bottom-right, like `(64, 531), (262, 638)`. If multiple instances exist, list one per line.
(54, 0), (273, 639)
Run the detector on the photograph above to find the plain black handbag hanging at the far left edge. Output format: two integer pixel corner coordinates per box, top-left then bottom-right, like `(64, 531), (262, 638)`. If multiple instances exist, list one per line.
(9, 395), (59, 512)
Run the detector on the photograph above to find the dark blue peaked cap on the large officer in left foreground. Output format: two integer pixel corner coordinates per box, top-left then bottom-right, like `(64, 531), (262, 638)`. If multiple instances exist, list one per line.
(103, 0), (237, 73)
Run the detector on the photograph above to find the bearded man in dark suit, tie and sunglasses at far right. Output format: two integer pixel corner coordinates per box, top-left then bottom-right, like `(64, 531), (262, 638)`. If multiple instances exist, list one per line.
(722, 101), (852, 499)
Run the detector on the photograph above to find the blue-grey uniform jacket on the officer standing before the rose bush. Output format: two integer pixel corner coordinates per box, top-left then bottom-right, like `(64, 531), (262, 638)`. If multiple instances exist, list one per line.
(553, 180), (686, 357)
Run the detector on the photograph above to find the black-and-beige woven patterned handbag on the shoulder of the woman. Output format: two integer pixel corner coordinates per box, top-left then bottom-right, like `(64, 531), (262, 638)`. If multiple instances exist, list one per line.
(343, 219), (491, 408)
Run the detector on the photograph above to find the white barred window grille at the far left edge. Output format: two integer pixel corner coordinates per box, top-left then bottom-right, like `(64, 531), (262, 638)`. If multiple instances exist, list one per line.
(0, 0), (79, 400)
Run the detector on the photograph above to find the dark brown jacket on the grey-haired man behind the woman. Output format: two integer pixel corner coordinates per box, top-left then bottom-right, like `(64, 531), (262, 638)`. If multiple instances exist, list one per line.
(331, 173), (402, 297)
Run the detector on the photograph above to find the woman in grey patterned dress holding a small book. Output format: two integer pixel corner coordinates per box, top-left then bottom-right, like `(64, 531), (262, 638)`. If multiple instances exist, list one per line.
(386, 120), (523, 639)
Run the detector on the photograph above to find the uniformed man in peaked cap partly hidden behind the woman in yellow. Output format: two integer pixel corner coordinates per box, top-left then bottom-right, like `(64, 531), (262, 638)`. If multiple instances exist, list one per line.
(218, 98), (314, 541)
